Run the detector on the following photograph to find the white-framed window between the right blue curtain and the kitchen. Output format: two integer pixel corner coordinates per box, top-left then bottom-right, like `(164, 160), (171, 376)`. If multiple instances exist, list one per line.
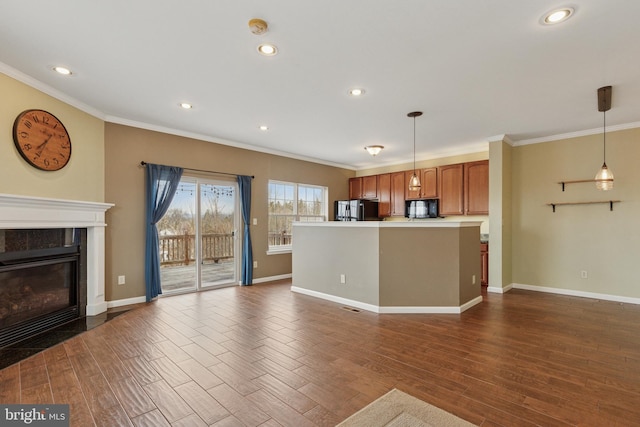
(269, 181), (328, 251)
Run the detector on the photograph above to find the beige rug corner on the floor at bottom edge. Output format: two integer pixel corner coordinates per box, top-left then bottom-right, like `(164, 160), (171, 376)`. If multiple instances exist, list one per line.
(338, 388), (474, 427)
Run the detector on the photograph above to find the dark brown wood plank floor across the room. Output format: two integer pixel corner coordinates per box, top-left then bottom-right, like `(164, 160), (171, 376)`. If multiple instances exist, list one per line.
(0, 282), (640, 427)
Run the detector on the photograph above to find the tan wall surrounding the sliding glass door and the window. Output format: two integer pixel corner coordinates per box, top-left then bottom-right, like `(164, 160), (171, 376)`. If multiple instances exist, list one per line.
(105, 123), (355, 301)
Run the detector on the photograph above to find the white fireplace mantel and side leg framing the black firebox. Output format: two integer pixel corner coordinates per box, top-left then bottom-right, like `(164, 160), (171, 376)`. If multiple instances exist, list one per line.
(0, 194), (114, 316)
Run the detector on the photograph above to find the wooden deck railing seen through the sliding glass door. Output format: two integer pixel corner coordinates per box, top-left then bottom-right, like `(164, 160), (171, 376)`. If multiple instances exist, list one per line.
(160, 233), (234, 265)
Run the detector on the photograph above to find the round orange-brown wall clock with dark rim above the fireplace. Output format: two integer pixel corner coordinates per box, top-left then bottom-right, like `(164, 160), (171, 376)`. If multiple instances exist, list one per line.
(13, 110), (71, 171)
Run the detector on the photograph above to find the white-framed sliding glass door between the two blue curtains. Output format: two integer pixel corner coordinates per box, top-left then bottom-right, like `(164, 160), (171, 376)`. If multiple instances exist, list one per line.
(158, 177), (240, 295)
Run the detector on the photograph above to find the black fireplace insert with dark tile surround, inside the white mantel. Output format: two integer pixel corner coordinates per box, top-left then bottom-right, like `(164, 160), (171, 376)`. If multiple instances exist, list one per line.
(0, 228), (87, 347)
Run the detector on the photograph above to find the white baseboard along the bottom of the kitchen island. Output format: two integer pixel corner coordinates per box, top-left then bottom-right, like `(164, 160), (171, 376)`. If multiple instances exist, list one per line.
(291, 286), (482, 314)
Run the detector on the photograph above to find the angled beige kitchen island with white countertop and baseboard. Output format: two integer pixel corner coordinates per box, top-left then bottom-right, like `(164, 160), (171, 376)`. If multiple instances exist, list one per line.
(291, 220), (482, 313)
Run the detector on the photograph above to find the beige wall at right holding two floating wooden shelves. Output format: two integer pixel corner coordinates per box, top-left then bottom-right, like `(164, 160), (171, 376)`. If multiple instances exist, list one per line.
(512, 129), (640, 298)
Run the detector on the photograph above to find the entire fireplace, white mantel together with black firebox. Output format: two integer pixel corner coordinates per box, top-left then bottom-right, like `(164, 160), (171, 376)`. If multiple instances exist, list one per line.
(0, 194), (113, 341)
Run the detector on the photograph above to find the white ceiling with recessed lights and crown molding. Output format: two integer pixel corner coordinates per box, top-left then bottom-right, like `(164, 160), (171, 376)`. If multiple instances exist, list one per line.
(0, 0), (640, 169)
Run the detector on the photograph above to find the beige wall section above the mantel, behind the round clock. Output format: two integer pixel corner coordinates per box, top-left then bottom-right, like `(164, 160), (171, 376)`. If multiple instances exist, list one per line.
(0, 74), (105, 202)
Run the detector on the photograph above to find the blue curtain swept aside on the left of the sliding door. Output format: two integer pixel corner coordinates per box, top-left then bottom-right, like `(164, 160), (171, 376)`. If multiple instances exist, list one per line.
(144, 163), (182, 302)
